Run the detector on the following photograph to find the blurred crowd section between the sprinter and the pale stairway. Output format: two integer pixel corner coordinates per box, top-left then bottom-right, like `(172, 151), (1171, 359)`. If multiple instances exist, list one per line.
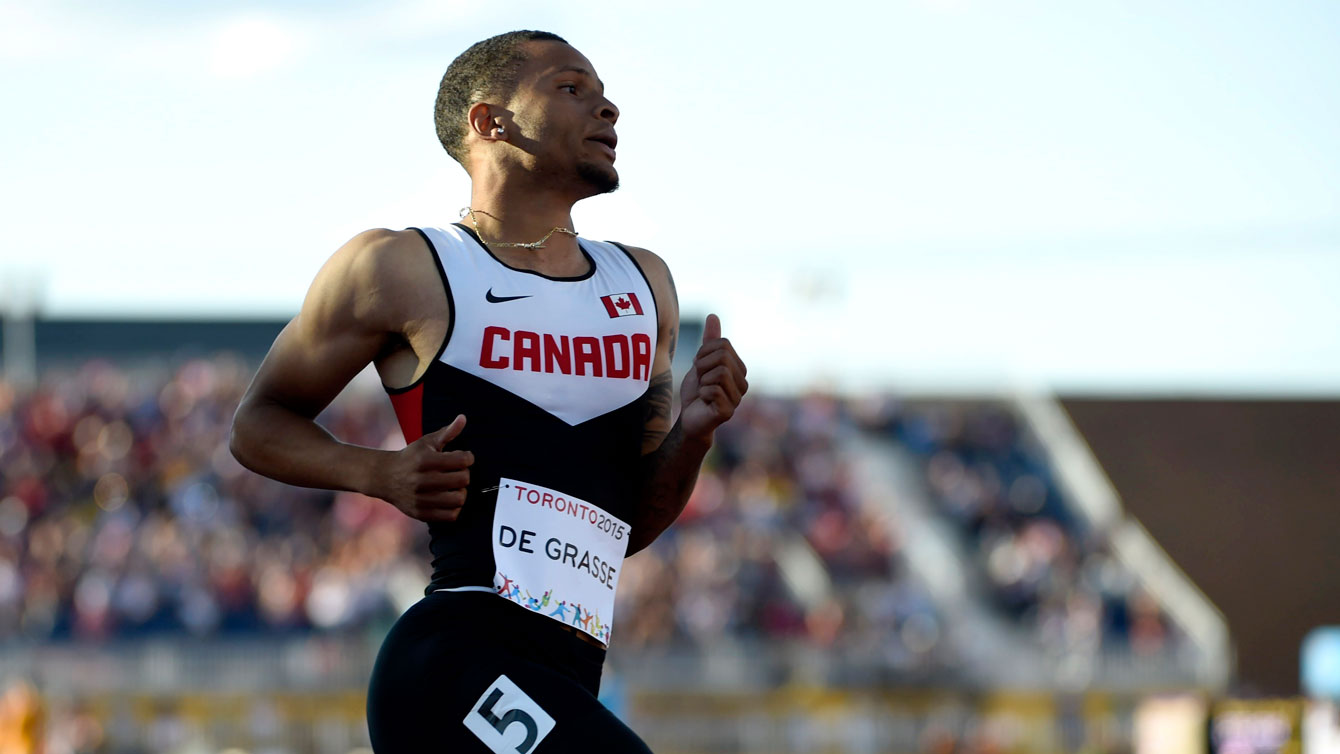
(616, 394), (941, 668)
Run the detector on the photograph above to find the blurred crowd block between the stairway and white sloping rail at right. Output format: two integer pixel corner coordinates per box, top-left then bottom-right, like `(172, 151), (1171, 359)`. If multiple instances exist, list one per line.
(868, 400), (1174, 654)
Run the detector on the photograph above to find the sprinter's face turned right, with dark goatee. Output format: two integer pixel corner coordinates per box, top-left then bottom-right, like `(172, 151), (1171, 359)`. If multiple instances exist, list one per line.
(508, 42), (619, 196)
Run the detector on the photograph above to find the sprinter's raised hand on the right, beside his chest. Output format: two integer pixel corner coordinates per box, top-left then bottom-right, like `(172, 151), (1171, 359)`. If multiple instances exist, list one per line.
(679, 315), (749, 442)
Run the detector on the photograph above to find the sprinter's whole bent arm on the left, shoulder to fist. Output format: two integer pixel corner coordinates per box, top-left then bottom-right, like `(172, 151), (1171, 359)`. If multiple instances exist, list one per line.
(229, 230), (474, 521)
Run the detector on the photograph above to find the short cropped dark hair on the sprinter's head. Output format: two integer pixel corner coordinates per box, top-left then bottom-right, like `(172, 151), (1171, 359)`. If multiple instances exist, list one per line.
(433, 31), (568, 165)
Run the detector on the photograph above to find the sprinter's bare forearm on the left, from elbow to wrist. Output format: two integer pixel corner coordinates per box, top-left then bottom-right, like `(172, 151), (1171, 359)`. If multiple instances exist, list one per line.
(229, 402), (391, 496)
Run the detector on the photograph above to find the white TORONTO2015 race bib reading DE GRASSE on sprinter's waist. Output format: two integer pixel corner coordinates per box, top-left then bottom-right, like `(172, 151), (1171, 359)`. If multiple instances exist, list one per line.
(493, 478), (631, 644)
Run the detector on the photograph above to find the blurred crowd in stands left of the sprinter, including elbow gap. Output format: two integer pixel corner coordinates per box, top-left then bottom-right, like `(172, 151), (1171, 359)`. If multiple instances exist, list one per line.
(0, 358), (426, 639)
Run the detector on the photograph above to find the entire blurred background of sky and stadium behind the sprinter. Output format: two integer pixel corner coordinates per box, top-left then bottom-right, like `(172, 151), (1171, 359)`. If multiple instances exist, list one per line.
(0, 0), (1340, 754)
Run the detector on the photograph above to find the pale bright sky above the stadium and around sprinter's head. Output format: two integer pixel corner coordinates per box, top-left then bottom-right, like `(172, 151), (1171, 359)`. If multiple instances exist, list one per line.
(0, 0), (1340, 396)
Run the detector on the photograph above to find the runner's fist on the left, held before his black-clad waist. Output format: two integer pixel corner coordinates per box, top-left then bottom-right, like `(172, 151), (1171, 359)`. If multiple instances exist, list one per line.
(377, 414), (474, 522)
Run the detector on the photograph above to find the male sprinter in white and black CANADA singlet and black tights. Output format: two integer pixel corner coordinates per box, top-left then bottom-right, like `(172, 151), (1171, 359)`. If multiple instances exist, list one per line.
(232, 31), (748, 754)
